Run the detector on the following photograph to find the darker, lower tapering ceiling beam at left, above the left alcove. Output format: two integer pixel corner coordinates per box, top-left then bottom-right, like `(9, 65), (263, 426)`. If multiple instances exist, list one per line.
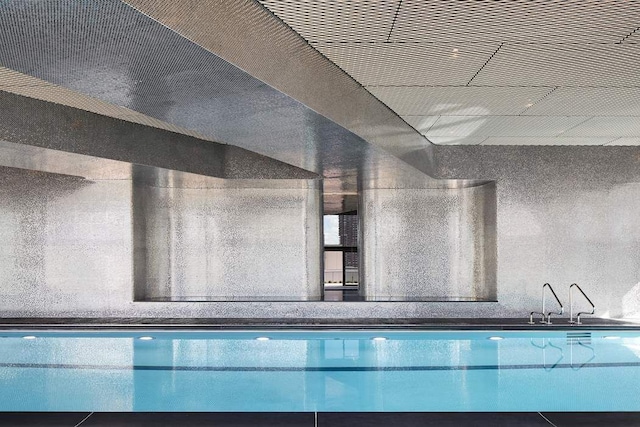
(0, 90), (317, 180)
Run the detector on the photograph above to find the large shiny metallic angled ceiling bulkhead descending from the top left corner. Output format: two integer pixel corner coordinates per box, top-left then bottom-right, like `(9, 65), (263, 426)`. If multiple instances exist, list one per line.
(0, 0), (451, 201)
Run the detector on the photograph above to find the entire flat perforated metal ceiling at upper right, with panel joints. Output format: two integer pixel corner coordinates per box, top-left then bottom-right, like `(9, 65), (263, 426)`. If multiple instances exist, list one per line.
(261, 0), (640, 145)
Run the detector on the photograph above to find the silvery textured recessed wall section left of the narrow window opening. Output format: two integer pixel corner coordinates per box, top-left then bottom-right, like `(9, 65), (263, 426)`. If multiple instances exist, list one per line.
(132, 169), (322, 302)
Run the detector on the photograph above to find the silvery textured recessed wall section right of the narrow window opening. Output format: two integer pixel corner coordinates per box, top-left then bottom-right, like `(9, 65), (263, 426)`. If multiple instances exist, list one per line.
(359, 183), (496, 301)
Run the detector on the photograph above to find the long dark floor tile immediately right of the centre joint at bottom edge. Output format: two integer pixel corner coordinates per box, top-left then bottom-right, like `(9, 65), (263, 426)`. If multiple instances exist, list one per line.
(318, 412), (550, 427)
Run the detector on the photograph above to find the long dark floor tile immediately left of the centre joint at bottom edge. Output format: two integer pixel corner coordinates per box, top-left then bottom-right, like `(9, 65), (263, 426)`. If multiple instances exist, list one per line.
(82, 412), (314, 427)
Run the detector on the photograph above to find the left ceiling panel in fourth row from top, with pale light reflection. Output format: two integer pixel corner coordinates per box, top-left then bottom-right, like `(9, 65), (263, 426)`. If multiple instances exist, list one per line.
(426, 116), (588, 139)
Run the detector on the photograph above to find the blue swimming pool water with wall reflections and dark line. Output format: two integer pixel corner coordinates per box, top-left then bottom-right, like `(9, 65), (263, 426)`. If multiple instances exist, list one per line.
(0, 328), (640, 411)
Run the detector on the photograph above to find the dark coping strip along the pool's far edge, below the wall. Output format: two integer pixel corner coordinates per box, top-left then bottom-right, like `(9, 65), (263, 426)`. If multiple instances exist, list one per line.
(0, 317), (640, 331)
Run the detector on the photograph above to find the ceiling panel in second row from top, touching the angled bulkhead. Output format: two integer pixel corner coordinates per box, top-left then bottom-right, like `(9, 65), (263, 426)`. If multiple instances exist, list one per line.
(314, 44), (498, 86)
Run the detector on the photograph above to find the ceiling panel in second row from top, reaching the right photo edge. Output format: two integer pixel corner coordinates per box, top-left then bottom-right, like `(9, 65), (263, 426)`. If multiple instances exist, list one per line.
(473, 44), (640, 87)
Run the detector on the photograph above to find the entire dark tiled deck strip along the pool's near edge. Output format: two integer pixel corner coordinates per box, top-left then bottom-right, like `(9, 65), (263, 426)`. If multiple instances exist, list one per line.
(0, 412), (640, 427)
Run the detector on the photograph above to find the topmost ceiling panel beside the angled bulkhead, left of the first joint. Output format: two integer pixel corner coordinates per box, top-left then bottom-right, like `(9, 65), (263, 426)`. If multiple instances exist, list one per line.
(260, 0), (400, 43)
